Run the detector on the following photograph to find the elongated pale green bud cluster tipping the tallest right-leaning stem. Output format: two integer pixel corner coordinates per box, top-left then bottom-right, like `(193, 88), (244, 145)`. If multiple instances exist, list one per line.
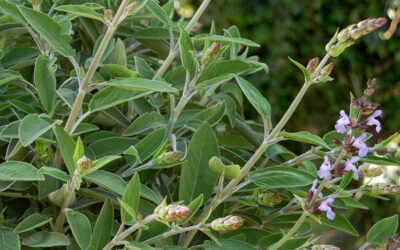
(325, 17), (386, 57)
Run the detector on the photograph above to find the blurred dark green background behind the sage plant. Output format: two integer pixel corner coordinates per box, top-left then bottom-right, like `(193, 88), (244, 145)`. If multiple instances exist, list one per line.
(184, 0), (400, 249)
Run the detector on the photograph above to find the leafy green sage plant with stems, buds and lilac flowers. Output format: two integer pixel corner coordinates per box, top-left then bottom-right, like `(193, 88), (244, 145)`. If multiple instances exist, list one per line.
(0, 0), (400, 250)
